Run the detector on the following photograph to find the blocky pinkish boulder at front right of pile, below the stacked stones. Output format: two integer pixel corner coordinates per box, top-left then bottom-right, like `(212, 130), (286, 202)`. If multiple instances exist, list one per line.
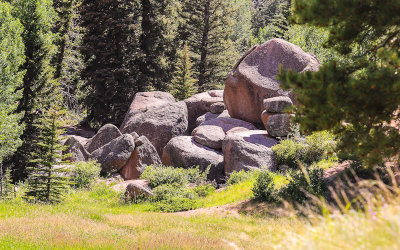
(222, 130), (278, 176)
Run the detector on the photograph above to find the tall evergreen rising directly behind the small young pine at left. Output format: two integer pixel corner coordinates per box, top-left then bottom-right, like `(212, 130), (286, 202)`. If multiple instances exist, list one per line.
(6, 0), (57, 180)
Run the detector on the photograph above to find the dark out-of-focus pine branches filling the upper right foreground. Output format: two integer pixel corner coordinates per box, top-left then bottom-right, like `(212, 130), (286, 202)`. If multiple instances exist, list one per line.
(279, 0), (400, 166)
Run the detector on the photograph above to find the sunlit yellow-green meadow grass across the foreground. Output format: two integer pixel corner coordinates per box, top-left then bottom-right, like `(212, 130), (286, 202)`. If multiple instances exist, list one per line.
(0, 175), (400, 249)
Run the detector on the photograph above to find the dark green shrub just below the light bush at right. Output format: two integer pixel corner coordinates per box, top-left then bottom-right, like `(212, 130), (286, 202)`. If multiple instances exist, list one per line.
(279, 167), (326, 203)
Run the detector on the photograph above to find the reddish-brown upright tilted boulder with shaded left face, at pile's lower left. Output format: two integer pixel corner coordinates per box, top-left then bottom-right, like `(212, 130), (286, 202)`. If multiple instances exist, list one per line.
(121, 136), (161, 180)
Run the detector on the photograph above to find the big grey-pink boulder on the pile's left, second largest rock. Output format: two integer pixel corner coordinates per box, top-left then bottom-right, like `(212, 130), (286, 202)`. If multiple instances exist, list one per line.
(121, 92), (188, 156)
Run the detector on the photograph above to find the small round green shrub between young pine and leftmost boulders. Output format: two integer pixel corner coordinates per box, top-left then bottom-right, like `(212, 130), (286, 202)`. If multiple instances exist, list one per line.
(72, 161), (101, 188)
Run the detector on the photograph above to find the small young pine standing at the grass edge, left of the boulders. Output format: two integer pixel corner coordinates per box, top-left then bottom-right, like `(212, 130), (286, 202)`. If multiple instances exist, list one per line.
(25, 105), (70, 203)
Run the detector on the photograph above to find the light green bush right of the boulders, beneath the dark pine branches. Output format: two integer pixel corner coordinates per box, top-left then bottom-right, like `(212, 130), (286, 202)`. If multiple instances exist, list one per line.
(272, 131), (337, 169)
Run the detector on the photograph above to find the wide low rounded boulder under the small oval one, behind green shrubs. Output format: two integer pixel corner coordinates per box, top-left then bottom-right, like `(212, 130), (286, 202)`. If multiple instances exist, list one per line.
(162, 136), (225, 183)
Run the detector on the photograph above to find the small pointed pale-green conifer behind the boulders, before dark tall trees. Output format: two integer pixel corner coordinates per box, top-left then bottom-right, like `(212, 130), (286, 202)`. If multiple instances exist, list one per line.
(171, 44), (197, 100)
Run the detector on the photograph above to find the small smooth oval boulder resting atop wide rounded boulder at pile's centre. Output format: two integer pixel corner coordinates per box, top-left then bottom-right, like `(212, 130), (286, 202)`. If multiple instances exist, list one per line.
(192, 125), (225, 149)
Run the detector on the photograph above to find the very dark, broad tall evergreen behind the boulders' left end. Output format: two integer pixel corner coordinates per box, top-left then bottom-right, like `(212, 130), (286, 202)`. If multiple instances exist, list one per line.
(81, 0), (141, 127)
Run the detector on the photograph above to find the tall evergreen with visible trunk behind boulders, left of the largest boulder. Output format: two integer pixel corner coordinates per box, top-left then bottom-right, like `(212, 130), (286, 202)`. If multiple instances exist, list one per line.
(181, 0), (239, 91)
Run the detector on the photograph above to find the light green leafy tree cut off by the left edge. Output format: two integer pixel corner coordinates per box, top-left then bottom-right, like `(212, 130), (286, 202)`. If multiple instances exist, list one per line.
(0, 2), (25, 164)
